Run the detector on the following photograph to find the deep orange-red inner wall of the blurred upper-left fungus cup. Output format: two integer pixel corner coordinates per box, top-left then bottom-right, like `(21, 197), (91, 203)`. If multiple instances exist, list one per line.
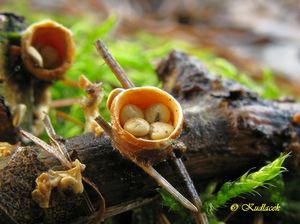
(30, 27), (67, 69)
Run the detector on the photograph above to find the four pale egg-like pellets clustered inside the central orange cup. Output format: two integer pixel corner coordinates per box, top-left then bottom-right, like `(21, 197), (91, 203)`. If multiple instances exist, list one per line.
(120, 103), (174, 140)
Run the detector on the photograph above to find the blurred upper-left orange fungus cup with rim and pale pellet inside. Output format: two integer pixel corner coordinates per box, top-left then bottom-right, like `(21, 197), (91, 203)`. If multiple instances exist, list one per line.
(21, 20), (75, 80)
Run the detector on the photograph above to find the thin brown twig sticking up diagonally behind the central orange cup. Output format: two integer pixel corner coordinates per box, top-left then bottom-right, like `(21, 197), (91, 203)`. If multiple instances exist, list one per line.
(95, 40), (134, 89)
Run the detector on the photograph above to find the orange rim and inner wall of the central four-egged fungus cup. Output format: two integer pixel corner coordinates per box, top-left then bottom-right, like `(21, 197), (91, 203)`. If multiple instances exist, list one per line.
(111, 87), (183, 142)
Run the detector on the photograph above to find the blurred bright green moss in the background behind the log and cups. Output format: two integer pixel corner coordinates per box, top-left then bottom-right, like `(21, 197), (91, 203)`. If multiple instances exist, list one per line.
(0, 0), (284, 138)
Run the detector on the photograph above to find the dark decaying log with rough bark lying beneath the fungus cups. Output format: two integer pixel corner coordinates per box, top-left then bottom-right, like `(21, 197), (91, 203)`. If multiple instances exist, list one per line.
(0, 51), (300, 223)
